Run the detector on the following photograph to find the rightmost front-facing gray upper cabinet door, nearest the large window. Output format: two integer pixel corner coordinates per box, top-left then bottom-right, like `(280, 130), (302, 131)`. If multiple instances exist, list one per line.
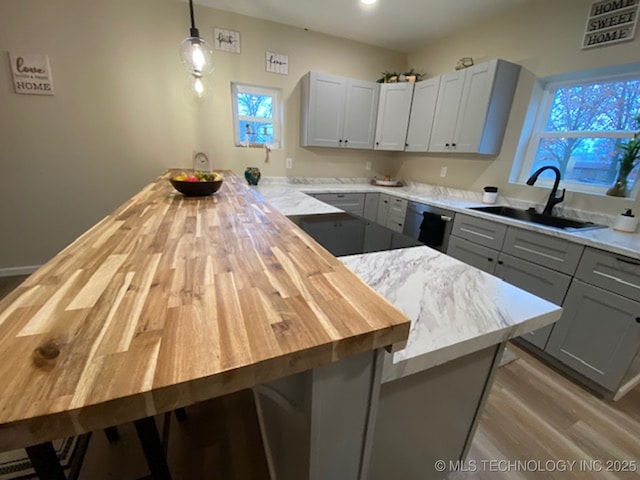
(453, 60), (497, 153)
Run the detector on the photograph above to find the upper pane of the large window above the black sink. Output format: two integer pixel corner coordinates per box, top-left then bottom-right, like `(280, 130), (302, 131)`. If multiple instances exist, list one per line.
(546, 80), (640, 132)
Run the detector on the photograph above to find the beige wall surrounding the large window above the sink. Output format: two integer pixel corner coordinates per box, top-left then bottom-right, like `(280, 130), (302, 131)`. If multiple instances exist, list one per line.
(396, 0), (640, 213)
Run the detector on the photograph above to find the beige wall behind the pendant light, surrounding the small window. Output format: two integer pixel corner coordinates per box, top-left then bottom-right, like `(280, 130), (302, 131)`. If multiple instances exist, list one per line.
(0, 0), (406, 269)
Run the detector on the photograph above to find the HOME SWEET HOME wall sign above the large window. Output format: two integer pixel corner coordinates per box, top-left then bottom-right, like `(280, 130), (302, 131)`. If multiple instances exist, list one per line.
(582, 0), (640, 50)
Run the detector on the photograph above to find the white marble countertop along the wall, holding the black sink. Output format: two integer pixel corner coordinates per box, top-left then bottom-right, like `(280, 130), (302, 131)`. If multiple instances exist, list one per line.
(253, 177), (640, 260)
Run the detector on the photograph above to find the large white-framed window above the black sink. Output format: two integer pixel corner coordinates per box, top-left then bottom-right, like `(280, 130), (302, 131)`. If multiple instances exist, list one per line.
(512, 65), (640, 194)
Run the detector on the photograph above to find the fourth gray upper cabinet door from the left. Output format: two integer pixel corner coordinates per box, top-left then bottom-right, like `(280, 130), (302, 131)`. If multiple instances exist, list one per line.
(405, 77), (440, 152)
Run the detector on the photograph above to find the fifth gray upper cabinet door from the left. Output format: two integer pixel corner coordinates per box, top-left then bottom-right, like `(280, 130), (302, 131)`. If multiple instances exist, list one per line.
(429, 70), (465, 152)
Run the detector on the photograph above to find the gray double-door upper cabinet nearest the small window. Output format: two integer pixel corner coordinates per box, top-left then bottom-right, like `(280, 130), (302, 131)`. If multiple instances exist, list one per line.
(300, 72), (379, 149)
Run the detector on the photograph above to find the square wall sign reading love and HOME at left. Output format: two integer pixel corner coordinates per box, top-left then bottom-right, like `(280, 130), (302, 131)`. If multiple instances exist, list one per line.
(9, 53), (54, 95)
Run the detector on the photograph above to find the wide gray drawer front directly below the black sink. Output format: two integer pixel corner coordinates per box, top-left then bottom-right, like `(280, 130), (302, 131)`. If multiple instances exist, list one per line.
(503, 227), (584, 275)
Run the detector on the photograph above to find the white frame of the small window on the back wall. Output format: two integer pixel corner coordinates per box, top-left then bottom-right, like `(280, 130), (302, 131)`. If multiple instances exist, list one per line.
(231, 82), (283, 149)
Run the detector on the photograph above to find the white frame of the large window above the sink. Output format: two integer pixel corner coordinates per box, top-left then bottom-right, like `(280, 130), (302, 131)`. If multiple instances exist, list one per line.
(510, 63), (640, 199)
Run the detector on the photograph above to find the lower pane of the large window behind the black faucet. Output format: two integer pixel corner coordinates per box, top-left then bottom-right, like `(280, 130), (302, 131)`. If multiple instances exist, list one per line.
(529, 138), (638, 186)
